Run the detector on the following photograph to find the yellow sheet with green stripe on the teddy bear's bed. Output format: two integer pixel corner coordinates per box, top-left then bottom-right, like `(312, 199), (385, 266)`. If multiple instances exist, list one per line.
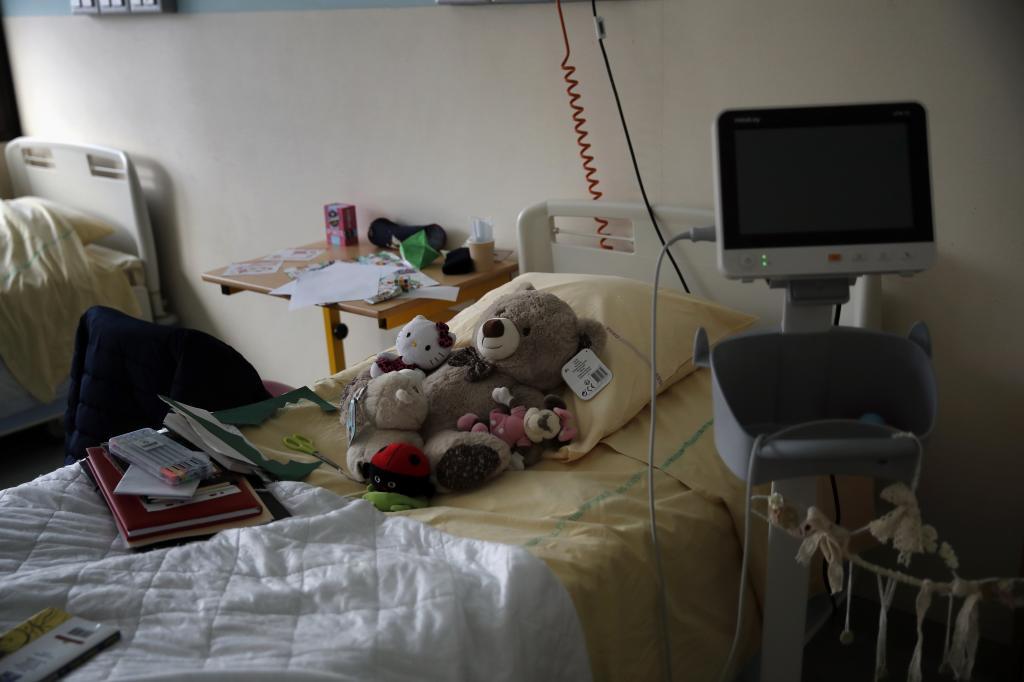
(246, 366), (764, 680)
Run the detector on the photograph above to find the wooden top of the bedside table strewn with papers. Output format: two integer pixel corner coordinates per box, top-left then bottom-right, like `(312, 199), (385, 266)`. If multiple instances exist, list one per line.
(203, 242), (519, 329)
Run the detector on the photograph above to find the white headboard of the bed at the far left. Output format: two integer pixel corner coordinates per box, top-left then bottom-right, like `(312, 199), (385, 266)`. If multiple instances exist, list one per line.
(6, 137), (166, 319)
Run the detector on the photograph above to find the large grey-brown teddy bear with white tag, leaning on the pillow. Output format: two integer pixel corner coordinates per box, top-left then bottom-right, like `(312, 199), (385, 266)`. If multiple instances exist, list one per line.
(420, 286), (605, 492)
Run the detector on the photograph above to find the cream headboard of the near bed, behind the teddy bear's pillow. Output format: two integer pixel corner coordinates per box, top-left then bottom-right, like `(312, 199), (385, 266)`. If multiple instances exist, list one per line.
(516, 200), (882, 329)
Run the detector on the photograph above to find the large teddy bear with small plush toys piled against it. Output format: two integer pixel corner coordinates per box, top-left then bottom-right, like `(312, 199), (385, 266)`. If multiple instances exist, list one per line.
(342, 286), (605, 497)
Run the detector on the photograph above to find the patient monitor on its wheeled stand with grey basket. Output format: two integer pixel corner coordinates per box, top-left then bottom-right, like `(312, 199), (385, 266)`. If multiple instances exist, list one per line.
(704, 103), (937, 680)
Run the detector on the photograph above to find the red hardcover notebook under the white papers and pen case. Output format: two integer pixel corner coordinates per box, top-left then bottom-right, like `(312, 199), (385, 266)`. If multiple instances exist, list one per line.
(86, 447), (263, 541)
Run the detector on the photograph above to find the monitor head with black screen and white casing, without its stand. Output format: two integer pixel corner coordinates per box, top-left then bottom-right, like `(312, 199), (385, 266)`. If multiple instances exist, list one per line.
(714, 102), (935, 281)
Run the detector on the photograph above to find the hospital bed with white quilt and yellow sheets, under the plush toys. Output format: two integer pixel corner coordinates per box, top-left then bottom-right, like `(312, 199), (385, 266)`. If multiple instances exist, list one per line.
(0, 183), (880, 680)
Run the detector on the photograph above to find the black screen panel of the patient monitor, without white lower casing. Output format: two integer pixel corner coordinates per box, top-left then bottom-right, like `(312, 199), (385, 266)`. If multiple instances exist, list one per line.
(719, 105), (932, 248)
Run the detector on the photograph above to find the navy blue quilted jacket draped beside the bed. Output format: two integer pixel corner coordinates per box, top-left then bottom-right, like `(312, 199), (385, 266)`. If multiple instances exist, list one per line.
(65, 305), (270, 464)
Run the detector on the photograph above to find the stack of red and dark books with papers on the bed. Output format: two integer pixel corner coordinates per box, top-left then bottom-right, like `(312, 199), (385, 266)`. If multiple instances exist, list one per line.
(81, 447), (289, 549)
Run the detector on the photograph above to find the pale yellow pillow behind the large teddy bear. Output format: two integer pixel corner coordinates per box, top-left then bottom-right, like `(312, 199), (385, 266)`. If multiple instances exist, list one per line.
(449, 272), (755, 460)
